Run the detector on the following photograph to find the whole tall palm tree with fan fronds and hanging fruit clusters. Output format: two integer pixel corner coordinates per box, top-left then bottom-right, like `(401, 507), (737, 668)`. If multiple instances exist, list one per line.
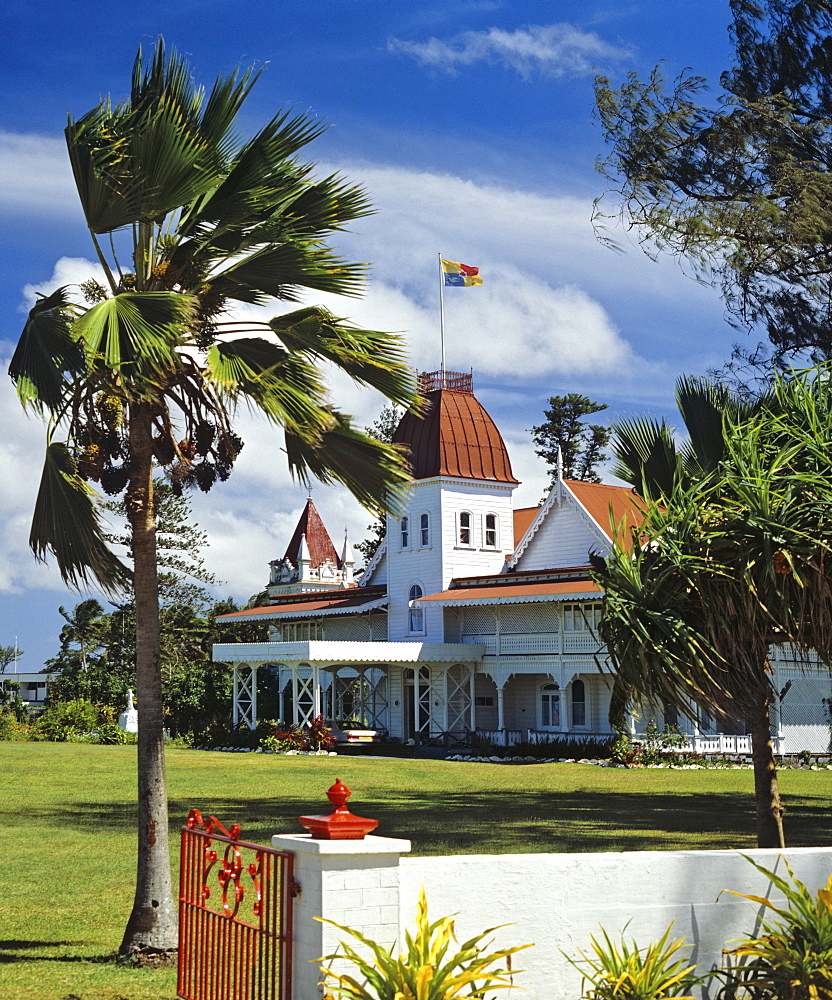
(10, 40), (415, 953)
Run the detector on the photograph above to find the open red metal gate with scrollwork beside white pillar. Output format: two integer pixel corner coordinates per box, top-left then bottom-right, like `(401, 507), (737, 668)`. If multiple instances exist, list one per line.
(176, 809), (300, 1000)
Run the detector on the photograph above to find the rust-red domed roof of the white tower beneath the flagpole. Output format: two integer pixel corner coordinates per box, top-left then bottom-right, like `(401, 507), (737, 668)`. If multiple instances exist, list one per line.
(393, 372), (518, 483)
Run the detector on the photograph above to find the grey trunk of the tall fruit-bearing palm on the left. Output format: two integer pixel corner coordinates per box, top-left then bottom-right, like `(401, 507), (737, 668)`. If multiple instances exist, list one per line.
(119, 403), (177, 955)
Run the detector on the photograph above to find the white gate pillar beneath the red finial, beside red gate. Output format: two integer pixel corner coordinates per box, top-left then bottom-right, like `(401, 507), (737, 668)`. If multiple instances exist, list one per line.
(272, 834), (410, 1000)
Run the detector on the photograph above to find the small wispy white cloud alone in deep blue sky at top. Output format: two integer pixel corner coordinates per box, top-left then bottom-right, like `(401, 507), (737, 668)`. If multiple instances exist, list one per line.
(388, 23), (631, 79)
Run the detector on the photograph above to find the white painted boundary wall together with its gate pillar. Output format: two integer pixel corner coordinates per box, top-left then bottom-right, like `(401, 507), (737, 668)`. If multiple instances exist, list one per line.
(272, 836), (832, 1000)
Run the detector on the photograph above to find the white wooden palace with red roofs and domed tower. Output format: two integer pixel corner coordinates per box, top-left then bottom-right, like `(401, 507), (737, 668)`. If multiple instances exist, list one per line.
(214, 372), (832, 753)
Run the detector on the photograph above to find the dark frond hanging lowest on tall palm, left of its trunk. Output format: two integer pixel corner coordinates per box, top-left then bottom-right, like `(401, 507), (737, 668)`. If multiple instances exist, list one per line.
(29, 442), (132, 596)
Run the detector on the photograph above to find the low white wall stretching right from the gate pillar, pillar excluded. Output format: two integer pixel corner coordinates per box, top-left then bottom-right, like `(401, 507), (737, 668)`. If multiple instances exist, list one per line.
(401, 847), (832, 1000)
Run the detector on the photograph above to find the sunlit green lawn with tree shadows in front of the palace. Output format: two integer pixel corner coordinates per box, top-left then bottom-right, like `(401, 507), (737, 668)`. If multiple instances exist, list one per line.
(0, 743), (832, 1000)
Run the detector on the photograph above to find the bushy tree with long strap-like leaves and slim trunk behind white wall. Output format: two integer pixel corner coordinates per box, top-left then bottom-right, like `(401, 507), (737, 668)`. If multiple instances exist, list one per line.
(594, 372), (832, 847)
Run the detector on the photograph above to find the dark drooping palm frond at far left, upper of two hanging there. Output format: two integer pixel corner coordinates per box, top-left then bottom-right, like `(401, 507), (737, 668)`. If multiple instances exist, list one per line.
(9, 287), (85, 414)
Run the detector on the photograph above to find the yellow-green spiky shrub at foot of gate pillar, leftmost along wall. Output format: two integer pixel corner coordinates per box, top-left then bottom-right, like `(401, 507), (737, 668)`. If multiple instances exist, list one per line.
(315, 888), (531, 1000)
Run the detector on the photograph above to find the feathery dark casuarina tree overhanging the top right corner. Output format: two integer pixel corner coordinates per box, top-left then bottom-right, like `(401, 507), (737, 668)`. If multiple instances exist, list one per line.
(596, 0), (832, 372)
